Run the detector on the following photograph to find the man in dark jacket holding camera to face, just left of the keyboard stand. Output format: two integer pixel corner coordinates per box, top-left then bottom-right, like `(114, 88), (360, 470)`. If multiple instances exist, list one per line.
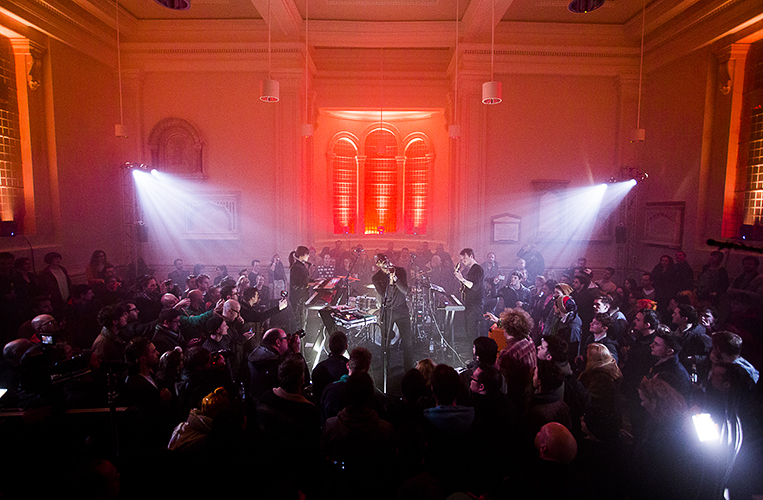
(246, 328), (300, 404)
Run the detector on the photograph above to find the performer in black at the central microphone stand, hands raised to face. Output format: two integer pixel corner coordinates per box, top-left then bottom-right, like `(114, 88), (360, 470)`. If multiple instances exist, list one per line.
(372, 253), (413, 371)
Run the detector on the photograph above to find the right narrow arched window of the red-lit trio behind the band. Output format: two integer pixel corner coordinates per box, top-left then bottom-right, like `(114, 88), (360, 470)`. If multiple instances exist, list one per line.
(403, 137), (432, 234)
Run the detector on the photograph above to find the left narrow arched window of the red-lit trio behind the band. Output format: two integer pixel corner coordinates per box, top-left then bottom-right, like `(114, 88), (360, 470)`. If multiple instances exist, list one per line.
(332, 137), (358, 234)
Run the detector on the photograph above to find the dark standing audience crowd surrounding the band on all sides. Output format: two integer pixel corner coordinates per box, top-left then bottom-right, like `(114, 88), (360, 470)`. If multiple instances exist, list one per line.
(0, 241), (763, 500)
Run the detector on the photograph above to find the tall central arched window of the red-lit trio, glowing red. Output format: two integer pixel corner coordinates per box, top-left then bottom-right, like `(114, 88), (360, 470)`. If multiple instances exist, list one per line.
(363, 128), (398, 234)
